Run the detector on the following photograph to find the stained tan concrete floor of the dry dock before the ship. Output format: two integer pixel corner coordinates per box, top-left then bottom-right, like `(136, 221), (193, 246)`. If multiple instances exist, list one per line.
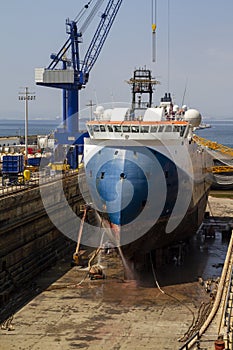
(0, 252), (209, 350)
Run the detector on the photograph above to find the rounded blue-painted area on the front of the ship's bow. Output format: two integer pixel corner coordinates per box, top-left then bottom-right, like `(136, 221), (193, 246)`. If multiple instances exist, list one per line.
(86, 147), (178, 226)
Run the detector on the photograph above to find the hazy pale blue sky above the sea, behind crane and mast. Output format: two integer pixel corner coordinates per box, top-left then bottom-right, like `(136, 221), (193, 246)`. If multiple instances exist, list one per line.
(0, 0), (233, 119)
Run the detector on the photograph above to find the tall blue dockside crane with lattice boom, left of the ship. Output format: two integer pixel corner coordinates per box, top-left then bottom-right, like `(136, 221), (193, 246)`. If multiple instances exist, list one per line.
(35, 0), (122, 157)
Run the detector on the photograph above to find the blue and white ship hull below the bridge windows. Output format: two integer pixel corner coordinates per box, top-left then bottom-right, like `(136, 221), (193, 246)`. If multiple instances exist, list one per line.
(85, 139), (210, 259)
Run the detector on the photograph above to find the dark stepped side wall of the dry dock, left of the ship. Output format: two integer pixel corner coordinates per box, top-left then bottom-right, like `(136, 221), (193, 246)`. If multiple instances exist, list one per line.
(0, 174), (90, 304)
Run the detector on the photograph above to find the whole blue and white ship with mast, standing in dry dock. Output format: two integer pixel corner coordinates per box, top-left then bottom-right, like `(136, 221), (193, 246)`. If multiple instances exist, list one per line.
(84, 67), (212, 262)
